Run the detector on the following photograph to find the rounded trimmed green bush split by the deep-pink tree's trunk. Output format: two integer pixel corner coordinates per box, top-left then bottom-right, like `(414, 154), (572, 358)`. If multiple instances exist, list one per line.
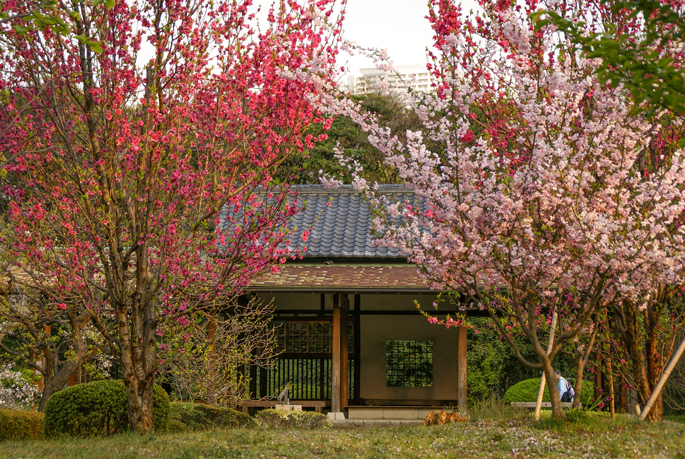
(45, 380), (169, 438)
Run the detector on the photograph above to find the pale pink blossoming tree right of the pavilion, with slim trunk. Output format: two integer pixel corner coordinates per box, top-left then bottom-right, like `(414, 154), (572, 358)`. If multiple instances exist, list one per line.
(329, 0), (685, 418)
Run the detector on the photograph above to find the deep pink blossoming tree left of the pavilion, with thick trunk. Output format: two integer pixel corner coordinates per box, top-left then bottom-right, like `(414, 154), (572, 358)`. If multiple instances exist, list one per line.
(0, 0), (342, 433)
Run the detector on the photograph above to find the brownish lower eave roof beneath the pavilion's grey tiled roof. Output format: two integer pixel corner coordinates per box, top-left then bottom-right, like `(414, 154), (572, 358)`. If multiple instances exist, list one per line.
(250, 263), (431, 292)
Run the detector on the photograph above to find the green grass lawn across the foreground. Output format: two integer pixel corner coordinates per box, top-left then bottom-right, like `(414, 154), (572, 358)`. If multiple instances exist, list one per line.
(0, 416), (685, 458)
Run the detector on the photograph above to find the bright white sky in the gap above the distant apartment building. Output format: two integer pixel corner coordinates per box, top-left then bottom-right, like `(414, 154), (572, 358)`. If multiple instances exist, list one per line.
(338, 0), (475, 73)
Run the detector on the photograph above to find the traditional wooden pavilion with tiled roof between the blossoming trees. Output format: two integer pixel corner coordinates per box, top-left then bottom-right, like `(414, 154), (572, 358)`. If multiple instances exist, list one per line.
(242, 186), (466, 412)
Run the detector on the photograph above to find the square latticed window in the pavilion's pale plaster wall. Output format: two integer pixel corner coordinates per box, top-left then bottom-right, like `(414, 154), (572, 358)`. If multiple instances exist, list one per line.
(385, 340), (433, 387)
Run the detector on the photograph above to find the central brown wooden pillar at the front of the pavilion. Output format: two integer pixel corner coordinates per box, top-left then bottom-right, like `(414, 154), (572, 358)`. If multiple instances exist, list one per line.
(331, 293), (349, 413)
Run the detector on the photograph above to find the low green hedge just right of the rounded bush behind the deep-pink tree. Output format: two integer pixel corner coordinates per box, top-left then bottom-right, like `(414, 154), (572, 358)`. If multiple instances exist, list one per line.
(168, 402), (254, 432)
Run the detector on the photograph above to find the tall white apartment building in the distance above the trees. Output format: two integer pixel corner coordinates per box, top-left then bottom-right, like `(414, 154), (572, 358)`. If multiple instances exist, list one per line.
(347, 64), (433, 94)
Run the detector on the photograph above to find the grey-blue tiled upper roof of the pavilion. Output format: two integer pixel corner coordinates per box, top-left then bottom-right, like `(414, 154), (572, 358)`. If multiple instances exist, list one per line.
(222, 185), (415, 259)
